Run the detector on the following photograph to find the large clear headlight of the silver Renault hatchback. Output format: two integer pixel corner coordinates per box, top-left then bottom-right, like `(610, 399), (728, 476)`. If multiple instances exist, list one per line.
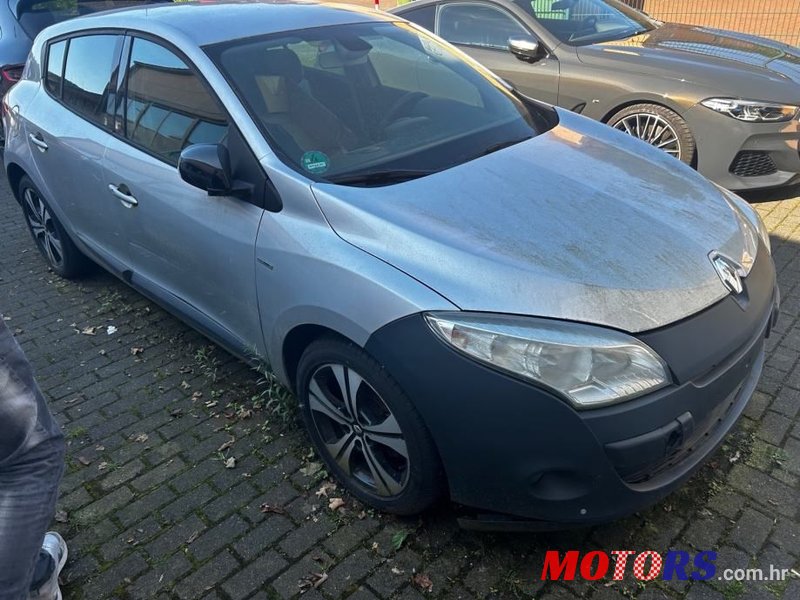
(426, 313), (670, 409)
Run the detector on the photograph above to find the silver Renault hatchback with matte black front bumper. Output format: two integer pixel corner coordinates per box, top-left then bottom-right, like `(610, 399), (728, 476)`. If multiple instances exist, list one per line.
(3, 2), (778, 527)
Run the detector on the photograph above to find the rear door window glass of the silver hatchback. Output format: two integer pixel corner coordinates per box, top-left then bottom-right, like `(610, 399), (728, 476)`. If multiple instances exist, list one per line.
(60, 34), (122, 129)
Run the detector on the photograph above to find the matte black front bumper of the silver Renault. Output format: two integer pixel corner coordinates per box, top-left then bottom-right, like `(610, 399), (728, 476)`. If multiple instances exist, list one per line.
(366, 243), (777, 528)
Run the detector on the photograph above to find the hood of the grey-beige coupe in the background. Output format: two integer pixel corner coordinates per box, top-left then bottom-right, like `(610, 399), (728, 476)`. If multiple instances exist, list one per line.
(578, 23), (800, 91)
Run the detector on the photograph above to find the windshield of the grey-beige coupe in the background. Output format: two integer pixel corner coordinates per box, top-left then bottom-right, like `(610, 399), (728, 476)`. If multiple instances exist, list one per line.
(515, 0), (657, 46)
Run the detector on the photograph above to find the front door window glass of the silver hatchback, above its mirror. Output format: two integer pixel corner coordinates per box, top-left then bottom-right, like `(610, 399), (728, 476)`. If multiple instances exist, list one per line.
(119, 38), (228, 165)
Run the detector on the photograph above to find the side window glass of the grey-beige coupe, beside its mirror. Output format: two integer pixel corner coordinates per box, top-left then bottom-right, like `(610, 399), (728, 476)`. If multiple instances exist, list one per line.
(438, 2), (528, 50)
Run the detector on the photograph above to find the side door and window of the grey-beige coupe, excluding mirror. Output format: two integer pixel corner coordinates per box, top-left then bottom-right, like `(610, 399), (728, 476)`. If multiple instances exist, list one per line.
(436, 2), (559, 104)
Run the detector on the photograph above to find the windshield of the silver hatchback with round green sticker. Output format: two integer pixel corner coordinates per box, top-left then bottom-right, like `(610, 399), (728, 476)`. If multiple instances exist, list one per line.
(206, 23), (556, 185)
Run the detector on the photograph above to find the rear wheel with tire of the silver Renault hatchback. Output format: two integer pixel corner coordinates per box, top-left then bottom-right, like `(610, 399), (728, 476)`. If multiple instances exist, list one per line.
(18, 175), (90, 279)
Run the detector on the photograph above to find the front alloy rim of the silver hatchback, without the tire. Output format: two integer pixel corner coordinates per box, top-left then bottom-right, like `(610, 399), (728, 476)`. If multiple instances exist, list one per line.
(308, 364), (410, 497)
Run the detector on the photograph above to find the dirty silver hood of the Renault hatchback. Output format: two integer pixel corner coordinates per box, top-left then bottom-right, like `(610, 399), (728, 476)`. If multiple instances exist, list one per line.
(312, 110), (749, 332)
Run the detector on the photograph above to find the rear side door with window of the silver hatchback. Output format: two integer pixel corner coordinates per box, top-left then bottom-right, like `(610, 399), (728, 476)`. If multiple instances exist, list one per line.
(25, 32), (127, 271)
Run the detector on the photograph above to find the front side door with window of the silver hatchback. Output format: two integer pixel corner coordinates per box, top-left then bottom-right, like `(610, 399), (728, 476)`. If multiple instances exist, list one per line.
(103, 37), (263, 354)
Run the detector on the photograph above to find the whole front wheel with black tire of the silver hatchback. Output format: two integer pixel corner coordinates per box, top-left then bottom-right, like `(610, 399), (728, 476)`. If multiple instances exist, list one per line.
(296, 337), (445, 515)
